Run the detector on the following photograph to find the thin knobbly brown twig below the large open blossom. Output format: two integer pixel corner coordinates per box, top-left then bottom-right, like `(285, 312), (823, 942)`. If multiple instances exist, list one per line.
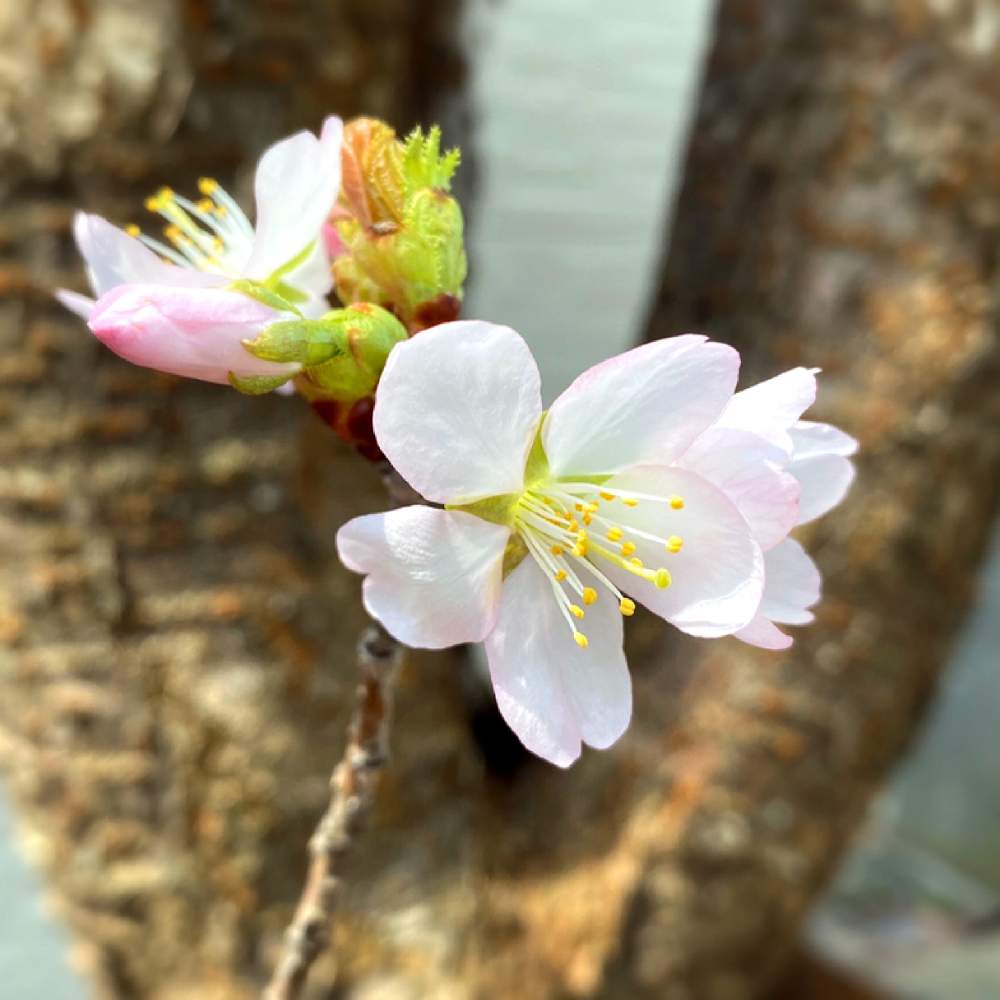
(264, 624), (403, 1000)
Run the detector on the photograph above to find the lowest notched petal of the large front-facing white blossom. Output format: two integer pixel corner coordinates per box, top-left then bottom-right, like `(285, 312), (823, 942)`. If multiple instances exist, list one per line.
(486, 558), (632, 767)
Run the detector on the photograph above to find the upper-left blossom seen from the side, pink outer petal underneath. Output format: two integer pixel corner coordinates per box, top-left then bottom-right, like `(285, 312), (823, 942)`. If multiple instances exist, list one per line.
(57, 117), (343, 383)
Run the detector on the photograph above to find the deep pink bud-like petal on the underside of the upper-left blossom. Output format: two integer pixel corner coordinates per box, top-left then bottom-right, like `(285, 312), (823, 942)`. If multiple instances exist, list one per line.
(89, 285), (299, 384)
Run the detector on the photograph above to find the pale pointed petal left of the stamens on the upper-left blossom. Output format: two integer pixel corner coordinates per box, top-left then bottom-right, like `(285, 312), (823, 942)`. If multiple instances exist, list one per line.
(73, 212), (227, 297)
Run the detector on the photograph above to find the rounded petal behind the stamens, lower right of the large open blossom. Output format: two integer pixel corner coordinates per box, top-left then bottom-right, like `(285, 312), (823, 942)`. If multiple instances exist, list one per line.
(596, 466), (764, 638)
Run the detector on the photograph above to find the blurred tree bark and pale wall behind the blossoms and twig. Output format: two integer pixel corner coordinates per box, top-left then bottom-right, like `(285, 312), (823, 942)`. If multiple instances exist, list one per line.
(0, 0), (1000, 1000)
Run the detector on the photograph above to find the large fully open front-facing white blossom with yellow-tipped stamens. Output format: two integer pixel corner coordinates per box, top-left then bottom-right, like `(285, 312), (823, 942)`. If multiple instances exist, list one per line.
(337, 322), (764, 766)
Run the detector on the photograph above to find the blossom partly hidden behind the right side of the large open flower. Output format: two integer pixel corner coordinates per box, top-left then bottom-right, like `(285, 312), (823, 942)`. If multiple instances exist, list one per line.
(678, 368), (857, 649)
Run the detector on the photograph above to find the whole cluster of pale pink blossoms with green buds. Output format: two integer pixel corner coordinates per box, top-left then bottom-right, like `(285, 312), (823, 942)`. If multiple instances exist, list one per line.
(59, 118), (856, 766)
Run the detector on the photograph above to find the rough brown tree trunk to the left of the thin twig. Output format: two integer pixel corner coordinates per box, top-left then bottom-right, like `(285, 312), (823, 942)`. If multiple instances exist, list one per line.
(0, 0), (461, 998)
